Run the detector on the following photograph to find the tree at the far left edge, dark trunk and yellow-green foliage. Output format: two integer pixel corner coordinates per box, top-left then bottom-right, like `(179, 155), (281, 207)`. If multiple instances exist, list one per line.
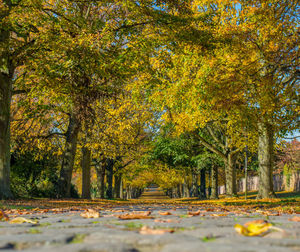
(0, 0), (47, 198)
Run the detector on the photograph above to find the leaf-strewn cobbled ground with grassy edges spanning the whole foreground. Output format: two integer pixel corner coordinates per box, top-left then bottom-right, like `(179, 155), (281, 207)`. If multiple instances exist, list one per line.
(0, 190), (300, 252)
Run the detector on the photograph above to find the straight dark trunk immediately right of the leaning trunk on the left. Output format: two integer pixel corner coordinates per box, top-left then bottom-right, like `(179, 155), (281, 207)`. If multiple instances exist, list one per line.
(81, 147), (91, 199)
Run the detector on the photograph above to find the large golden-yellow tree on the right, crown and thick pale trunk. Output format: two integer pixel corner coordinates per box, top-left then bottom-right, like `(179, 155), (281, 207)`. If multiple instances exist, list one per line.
(135, 1), (299, 198)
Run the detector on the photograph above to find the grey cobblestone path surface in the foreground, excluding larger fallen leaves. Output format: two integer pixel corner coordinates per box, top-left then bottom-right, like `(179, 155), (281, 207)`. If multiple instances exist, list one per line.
(0, 190), (300, 252)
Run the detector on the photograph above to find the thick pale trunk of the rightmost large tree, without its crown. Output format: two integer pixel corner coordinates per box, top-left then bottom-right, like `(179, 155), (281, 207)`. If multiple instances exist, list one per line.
(257, 122), (275, 199)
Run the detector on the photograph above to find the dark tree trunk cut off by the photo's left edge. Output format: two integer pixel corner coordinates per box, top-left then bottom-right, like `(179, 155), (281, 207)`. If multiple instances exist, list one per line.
(0, 29), (14, 199)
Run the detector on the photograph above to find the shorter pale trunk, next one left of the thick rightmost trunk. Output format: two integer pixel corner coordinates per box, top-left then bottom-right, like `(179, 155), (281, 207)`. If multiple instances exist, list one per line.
(225, 153), (237, 197)
